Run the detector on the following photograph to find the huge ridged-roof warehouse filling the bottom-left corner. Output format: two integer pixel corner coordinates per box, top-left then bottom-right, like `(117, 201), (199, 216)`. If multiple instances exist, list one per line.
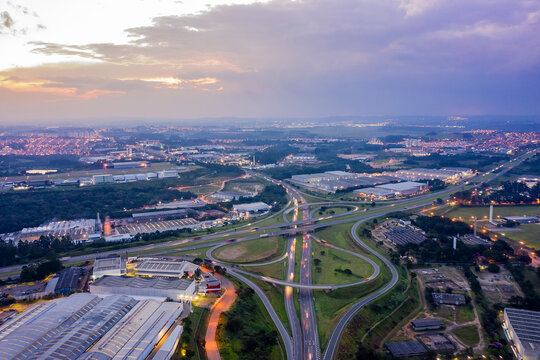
(0, 293), (183, 360)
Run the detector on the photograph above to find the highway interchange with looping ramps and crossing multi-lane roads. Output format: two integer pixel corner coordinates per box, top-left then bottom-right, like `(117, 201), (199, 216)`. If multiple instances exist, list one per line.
(0, 149), (538, 360)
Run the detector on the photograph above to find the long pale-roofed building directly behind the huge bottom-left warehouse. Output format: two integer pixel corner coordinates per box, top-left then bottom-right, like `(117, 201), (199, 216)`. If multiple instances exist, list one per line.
(90, 275), (195, 301)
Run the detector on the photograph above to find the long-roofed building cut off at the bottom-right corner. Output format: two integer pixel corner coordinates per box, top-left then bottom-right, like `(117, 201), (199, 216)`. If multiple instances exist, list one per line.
(502, 308), (540, 360)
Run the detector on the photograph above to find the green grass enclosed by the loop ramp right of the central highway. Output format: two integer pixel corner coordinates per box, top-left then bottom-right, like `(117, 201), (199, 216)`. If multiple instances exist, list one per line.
(311, 242), (374, 284)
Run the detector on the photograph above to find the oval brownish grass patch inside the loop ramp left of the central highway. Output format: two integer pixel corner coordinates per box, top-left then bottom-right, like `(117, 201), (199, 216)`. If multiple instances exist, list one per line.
(213, 236), (285, 263)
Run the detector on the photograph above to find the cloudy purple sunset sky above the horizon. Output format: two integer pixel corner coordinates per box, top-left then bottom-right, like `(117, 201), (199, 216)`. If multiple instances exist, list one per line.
(0, 0), (540, 125)
